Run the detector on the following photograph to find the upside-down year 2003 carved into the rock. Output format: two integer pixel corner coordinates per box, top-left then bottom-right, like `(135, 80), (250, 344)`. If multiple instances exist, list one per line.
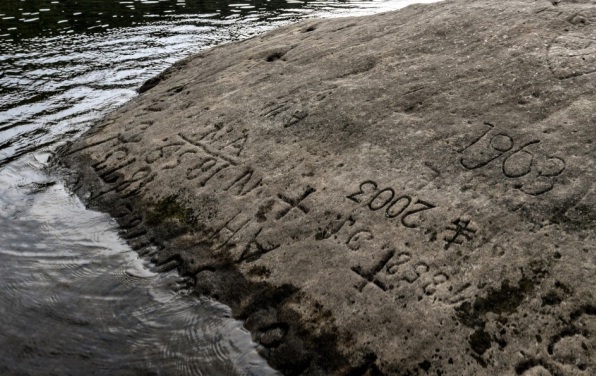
(346, 180), (436, 228)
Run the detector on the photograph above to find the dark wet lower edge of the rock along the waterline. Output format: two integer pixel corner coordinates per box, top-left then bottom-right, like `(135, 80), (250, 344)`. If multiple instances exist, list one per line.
(51, 146), (374, 376)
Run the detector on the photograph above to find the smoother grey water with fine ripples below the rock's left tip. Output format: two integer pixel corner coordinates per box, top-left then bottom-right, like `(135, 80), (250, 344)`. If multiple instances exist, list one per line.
(0, 154), (276, 375)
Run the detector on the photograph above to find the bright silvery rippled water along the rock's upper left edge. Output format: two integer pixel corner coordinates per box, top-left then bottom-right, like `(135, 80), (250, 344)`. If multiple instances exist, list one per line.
(0, 0), (428, 167)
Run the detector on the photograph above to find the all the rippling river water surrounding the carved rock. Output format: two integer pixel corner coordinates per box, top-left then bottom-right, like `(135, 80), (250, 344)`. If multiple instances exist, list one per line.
(0, 0), (438, 375)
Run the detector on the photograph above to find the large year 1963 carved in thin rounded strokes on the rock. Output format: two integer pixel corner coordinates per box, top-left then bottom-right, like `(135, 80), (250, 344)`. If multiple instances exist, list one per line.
(459, 123), (566, 196)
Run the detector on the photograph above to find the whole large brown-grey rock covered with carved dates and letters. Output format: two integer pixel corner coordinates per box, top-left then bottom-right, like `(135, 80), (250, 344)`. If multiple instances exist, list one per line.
(60, 0), (596, 376)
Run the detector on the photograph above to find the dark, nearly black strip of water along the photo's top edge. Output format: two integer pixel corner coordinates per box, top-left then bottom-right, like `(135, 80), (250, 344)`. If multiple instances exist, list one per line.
(0, 0), (428, 40)
